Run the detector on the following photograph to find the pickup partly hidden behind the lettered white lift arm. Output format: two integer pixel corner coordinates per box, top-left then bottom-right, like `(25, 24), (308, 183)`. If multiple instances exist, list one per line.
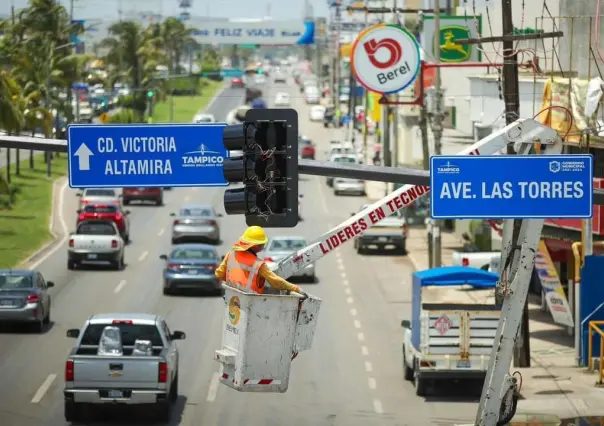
(351, 204), (407, 254)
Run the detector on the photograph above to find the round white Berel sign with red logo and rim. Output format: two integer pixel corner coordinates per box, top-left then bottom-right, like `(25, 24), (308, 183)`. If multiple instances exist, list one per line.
(351, 24), (421, 95)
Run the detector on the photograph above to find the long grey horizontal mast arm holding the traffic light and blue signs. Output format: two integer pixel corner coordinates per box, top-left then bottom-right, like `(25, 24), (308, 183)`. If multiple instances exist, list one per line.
(0, 135), (604, 206)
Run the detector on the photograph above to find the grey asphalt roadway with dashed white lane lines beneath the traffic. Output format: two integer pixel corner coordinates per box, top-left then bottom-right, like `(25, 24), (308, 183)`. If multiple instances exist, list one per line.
(0, 80), (476, 426)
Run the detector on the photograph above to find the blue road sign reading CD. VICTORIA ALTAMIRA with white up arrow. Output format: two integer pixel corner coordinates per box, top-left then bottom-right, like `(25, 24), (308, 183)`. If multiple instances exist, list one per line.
(67, 123), (228, 188)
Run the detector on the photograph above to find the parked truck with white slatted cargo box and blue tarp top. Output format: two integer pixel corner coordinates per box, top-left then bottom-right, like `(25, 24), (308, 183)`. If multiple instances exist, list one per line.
(401, 266), (501, 396)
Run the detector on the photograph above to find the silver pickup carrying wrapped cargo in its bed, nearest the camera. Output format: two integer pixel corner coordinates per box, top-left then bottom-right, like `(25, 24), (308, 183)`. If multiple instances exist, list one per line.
(64, 314), (186, 422)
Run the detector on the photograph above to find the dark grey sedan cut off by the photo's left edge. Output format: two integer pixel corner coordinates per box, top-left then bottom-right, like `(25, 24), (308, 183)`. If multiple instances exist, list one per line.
(0, 269), (54, 332)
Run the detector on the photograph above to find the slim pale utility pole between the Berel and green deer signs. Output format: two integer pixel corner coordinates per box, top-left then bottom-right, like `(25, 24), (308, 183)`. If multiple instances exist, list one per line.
(432, 0), (444, 268)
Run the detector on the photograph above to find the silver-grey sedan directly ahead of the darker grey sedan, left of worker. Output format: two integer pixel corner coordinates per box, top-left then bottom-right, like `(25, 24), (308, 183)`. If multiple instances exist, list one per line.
(170, 204), (222, 244)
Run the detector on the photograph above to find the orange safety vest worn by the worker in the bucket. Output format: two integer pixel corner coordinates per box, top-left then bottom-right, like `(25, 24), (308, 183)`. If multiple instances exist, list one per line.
(226, 250), (264, 294)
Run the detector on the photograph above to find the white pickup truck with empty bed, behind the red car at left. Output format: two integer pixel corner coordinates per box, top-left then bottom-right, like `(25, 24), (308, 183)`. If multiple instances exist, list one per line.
(67, 220), (124, 271)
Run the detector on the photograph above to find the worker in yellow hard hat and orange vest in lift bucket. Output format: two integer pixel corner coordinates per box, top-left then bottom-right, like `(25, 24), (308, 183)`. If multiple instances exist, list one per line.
(216, 226), (306, 296)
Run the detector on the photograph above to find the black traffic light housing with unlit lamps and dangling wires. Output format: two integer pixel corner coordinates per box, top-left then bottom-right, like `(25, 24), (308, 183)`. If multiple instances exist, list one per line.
(223, 109), (299, 228)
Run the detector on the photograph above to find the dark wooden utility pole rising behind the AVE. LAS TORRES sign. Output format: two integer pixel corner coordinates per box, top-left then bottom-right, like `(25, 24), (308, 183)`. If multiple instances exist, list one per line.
(496, 0), (531, 368)
